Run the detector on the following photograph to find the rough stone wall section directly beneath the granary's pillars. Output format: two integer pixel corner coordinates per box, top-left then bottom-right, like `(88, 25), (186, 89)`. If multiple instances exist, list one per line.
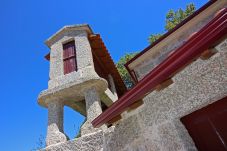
(40, 131), (103, 151)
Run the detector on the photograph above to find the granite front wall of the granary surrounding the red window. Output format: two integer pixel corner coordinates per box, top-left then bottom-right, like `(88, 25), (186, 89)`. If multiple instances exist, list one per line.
(48, 30), (94, 88)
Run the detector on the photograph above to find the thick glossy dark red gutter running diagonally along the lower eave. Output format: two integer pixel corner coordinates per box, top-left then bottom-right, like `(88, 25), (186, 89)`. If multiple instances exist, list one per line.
(92, 8), (227, 127)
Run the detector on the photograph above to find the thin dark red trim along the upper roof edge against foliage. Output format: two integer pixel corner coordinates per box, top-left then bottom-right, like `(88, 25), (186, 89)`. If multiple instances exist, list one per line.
(125, 0), (217, 79)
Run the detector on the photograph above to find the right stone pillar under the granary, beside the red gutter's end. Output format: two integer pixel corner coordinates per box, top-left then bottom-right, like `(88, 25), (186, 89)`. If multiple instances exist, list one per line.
(81, 87), (107, 135)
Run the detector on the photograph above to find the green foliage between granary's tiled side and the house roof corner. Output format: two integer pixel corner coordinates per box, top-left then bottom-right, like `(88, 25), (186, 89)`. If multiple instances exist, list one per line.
(116, 52), (137, 89)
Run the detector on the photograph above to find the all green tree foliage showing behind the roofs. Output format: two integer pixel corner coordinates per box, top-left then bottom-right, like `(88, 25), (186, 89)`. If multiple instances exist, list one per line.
(116, 3), (196, 89)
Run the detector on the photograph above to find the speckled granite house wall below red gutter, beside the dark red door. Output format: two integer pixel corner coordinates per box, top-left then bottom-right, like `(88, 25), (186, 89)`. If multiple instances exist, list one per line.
(104, 40), (227, 151)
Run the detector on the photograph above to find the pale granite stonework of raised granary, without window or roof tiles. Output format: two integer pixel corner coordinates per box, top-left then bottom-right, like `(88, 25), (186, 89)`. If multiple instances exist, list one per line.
(38, 25), (119, 149)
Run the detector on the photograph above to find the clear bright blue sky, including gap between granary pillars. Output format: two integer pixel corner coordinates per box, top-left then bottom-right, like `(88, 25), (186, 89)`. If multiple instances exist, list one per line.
(0, 0), (207, 151)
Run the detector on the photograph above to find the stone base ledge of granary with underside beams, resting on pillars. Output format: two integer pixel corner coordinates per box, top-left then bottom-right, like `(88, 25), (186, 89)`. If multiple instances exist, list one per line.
(38, 66), (116, 116)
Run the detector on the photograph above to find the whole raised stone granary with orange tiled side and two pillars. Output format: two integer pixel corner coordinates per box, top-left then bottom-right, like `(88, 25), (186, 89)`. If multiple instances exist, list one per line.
(39, 25), (126, 145)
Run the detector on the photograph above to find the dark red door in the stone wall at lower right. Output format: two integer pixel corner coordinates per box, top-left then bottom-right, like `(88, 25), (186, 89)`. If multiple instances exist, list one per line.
(181, 97), (227, 151)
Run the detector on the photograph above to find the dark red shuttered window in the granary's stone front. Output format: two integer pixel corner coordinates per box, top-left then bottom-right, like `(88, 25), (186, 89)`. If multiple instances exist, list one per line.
(63, 41), (77, 74)
